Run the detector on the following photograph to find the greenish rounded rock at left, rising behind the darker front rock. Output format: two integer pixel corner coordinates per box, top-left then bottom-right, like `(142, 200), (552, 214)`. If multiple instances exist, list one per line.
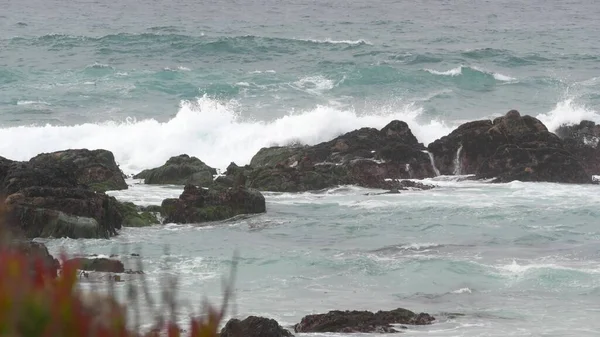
(29, 149), (127, 192)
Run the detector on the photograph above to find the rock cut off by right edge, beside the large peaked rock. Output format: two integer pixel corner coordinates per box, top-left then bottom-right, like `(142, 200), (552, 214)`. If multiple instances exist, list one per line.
(556, 121), (600, 175)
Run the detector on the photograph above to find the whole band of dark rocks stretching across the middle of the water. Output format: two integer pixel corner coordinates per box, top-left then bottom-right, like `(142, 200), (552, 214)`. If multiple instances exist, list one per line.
(0, 110), (600, 238)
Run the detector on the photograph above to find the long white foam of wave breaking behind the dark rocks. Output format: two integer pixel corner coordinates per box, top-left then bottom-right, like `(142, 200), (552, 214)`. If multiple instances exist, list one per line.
(0, 97), (450, 174)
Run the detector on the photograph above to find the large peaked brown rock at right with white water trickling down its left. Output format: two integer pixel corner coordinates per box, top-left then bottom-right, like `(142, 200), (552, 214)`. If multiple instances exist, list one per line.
(428, 110), (591, 183)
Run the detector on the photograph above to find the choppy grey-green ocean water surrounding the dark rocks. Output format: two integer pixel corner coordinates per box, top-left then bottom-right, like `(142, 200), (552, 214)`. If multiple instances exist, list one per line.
(0, 0), (600, 336)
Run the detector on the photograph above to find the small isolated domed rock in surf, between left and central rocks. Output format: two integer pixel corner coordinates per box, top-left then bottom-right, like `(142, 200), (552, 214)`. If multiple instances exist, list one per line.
(134, 154), (217, 186)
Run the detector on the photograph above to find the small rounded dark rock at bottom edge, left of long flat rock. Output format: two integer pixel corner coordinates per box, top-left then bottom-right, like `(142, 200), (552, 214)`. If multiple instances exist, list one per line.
(220, 316), (293, 337)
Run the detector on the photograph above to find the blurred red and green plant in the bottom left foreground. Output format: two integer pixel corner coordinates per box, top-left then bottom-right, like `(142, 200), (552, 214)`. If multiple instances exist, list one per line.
(0, 200), (235, 337)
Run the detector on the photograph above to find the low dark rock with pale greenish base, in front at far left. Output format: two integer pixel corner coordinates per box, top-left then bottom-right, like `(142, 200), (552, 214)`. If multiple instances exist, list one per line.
(5, 187), (122, 238)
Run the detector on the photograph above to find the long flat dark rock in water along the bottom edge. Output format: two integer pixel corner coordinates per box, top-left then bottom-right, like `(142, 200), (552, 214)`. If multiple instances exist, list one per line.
(294, 308), (435, 333)
